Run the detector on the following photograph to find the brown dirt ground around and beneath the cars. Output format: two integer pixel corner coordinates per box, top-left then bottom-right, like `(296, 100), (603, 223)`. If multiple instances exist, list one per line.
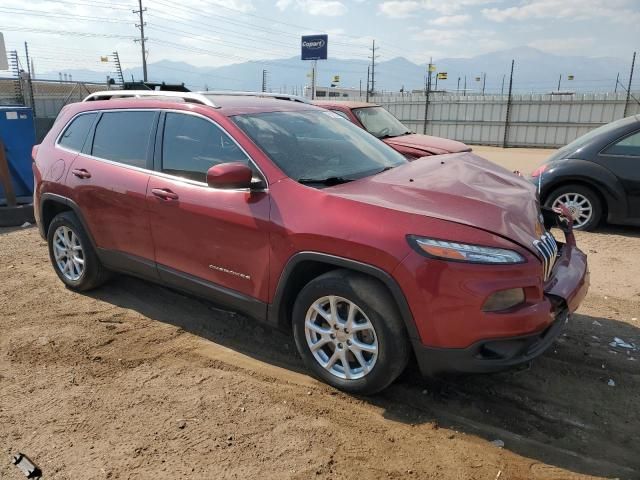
(0, 149), (640, 480)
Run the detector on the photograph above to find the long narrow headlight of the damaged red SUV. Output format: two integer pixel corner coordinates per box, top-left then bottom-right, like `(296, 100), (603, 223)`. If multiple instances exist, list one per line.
(407, 235), (525, 264)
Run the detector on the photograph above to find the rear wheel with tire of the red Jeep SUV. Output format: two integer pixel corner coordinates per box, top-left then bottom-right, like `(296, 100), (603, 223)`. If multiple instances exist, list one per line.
(47, 212), (109, 291)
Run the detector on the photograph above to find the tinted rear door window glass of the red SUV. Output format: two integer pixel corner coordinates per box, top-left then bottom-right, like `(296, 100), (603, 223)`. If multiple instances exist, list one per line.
(91, 111), (157, 168)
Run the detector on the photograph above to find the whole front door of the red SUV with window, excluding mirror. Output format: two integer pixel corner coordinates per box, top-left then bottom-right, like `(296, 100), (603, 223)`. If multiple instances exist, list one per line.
(147, 112), (270, 301)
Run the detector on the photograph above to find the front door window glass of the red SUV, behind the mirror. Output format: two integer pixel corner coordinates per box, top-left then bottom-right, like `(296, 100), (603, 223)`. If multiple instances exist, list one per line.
(162, 112), (249, 183)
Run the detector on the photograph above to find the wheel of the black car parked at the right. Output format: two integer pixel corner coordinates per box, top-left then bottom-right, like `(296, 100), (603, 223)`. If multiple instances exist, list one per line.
(545, 185), (602, 230)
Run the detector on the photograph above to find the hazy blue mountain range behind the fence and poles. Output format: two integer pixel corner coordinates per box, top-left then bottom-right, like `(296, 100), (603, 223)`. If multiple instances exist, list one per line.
(39, 47), (640, 93)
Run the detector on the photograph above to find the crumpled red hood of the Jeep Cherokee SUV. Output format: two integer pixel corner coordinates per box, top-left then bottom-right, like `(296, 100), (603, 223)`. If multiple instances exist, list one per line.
(324, 153), (542, 254)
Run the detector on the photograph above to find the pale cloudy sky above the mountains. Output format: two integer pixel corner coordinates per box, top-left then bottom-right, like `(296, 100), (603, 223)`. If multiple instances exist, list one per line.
(0, 0), (640, 78)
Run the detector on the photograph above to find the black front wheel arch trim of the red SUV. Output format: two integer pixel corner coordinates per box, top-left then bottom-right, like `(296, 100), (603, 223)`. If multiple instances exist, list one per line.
(267, 252), (419, 340)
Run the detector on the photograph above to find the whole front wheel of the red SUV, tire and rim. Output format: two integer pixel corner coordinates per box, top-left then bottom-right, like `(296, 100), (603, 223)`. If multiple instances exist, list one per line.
(293, 270), (410, 394)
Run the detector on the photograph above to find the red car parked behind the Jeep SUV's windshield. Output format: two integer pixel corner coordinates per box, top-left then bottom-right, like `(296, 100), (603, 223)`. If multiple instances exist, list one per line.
(313, 100), (471, 160)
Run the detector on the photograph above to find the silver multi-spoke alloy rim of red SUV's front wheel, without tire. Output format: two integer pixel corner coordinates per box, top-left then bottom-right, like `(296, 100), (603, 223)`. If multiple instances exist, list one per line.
(304, 295), (378, 380)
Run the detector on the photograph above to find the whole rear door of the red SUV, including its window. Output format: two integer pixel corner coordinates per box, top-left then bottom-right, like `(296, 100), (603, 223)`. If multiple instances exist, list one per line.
(67, 110), (160, 261)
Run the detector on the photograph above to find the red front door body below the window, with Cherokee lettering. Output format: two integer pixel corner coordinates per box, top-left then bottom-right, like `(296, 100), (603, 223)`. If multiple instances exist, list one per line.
(147, 176), (270, 301)
